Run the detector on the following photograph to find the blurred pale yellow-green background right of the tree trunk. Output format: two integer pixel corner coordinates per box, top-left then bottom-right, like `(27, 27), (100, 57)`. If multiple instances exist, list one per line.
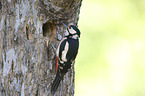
(75, 0), (145, 96)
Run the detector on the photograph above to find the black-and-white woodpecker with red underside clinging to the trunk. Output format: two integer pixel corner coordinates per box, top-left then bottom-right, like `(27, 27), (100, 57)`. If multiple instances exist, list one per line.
(51, 23), (80, 94)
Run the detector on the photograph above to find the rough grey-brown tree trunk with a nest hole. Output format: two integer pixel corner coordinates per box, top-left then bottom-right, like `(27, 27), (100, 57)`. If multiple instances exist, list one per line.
(0, 0), (82, 96)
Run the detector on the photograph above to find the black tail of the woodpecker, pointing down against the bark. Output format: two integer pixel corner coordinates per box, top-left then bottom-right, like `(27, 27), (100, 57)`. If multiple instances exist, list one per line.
(51, 70), (63, 94)
